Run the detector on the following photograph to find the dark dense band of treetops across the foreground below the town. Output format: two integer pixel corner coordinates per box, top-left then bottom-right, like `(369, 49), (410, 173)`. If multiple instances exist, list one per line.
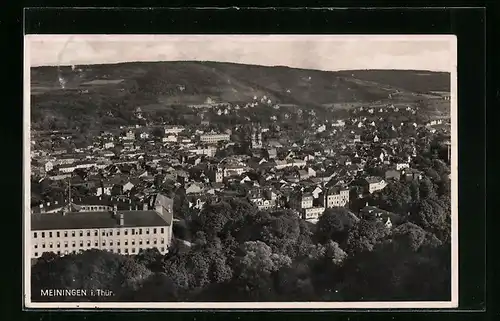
(32, 154), (451, 301)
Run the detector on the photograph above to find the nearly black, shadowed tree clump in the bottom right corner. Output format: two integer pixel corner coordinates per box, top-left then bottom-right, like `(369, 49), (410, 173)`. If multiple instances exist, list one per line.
(336, 242), (451, 301)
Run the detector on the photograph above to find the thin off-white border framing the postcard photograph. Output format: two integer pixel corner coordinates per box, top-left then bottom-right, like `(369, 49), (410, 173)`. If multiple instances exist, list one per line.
(23, 35), (458, 310)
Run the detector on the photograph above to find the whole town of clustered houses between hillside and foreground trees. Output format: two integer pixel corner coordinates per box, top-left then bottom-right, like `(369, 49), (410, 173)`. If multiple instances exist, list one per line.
(30, 93), (451, 259)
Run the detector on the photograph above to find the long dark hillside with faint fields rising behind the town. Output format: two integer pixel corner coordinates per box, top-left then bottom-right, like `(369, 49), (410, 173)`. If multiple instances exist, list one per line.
(31, 61), (450, 128)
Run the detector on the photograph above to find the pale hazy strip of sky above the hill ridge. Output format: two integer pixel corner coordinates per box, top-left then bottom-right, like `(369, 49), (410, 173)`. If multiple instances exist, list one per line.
(26, 35), (456, 72)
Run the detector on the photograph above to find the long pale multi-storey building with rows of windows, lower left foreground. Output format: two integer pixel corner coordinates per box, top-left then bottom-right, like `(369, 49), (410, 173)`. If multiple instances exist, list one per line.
(29, 194), (173, 258)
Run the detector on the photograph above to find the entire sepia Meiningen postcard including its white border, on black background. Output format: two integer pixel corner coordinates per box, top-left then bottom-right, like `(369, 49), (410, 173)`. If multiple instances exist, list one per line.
(23, 34), (458, 310)
